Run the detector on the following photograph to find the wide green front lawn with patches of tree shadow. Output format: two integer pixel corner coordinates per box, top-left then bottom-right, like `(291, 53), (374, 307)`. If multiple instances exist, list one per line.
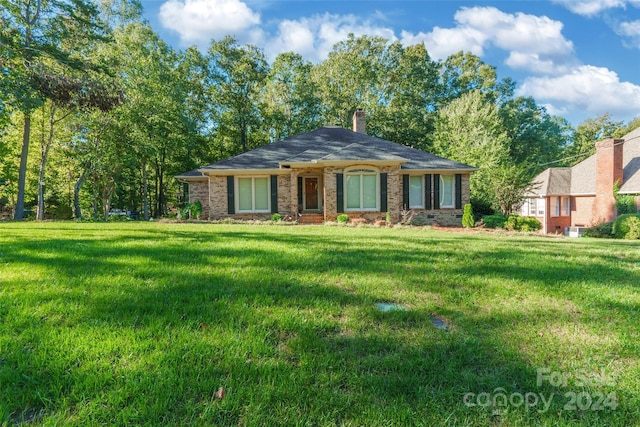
(0, 223), (640, 426)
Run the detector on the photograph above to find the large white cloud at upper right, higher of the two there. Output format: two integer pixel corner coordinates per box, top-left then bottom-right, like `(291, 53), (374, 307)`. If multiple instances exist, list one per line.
(402, 7), (575, 73)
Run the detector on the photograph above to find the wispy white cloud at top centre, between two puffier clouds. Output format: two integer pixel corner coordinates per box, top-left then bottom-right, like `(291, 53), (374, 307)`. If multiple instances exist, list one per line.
(266, 13), (396, 61)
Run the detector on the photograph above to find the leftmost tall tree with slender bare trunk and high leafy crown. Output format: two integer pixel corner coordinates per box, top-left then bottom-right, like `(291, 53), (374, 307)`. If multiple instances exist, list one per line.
(0, 0), (111, 220)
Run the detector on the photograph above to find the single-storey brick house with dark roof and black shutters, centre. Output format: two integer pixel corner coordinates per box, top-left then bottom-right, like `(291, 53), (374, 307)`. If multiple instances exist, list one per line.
(176, 110), (477, 225)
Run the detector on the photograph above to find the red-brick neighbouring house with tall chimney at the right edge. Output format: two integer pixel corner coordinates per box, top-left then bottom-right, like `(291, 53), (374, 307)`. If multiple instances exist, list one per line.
(521, 128), (640, 233)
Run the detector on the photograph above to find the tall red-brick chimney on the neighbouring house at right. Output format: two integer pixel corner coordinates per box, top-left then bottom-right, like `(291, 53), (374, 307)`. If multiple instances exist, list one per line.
(591, 138), (624, 224)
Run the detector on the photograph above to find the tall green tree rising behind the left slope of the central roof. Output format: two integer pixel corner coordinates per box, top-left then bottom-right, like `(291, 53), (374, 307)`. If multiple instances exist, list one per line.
(208, 36), (269, 156)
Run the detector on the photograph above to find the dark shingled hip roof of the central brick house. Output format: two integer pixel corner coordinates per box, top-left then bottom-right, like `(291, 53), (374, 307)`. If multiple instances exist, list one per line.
(177, 126), (477, 179)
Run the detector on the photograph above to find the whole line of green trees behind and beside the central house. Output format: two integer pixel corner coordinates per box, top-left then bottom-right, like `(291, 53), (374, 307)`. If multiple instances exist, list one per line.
(0, 0), (640, 219)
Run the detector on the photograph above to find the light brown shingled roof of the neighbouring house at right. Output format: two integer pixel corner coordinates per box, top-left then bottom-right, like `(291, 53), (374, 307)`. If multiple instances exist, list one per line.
(527, 128), (640, 196)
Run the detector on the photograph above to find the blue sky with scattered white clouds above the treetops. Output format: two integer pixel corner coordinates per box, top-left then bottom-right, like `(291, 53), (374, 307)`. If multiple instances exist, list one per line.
(142, 0), (640, 125)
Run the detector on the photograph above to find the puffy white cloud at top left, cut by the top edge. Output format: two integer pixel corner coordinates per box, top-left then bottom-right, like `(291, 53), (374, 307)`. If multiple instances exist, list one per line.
(159, 0), (260, 44)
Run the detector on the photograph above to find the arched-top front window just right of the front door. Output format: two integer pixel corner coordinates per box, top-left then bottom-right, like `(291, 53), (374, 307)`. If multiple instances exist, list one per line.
(344, 169), (380, 211)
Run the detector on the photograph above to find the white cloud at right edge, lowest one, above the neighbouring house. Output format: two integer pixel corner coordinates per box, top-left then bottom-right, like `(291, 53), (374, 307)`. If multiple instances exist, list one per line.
(517, 65), (640, 118)
